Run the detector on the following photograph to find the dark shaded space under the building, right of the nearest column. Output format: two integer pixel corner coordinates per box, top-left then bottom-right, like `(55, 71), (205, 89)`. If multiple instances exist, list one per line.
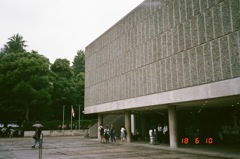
(178, 107), (240, 145)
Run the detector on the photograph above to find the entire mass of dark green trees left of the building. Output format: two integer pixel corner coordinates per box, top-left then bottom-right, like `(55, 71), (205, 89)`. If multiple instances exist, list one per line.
(0, 34), (85, 123)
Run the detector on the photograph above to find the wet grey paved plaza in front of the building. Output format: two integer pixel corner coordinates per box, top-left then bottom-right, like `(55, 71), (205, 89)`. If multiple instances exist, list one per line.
(0, 137), (240, 159)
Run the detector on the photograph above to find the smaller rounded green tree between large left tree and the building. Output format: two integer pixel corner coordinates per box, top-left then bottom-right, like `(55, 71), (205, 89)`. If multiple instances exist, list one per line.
(51, 56), (84, 120)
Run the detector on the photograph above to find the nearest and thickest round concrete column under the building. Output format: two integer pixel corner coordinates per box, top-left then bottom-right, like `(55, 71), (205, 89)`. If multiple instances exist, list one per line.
(168, 105), (178, 148)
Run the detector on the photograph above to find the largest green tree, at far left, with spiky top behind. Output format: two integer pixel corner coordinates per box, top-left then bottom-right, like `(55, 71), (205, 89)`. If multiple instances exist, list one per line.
(0, 34), (51, 122)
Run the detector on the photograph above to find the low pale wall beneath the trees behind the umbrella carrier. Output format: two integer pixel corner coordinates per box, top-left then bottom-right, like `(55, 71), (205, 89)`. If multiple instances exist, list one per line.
(24, 129), (89, 137)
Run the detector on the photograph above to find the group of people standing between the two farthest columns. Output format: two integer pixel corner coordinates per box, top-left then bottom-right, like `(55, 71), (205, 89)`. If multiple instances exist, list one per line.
(98, 124), (127, 143)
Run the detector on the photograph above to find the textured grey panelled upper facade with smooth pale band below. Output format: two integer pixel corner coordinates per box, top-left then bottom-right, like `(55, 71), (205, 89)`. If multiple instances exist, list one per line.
(84, 0), (240, 147)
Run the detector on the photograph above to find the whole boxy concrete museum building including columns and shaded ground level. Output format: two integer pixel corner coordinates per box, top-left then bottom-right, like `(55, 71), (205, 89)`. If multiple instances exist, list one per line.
(84, 0), (240, 148)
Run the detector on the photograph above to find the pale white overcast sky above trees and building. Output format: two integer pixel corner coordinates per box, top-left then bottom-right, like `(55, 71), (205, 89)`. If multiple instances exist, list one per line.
(0, 0), (143, 63)
